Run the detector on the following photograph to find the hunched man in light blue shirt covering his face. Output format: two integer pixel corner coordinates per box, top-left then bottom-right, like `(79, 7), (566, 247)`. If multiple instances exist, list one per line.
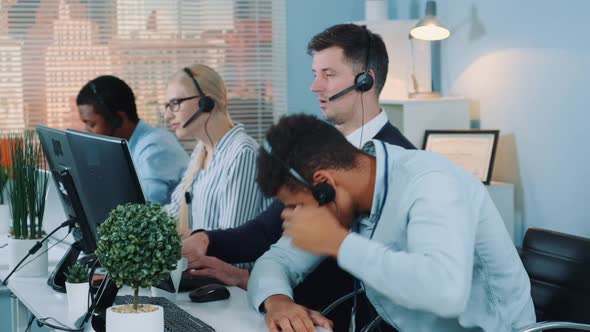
(248, 115), (535, 332)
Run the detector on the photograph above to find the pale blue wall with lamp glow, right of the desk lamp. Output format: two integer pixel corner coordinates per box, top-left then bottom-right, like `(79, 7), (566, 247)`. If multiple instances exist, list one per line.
(438, 0), (590, 237)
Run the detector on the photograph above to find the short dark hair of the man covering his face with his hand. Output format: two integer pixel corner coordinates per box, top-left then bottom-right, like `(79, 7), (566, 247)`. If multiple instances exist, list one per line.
(257, 114), (361, 197)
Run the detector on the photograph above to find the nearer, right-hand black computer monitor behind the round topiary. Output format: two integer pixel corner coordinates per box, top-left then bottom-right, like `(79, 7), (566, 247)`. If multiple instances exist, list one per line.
(66, 129), (145, 241)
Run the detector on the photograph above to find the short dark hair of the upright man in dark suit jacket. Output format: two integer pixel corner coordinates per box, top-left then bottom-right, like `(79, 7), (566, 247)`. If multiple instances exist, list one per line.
(307, 24), (389, 96)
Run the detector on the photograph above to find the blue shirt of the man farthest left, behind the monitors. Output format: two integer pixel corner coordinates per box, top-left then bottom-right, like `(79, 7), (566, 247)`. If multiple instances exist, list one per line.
(129, 120), (188, 205)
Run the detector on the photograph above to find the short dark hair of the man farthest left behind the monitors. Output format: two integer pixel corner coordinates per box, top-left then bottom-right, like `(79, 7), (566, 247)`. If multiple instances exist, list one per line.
(76, 75), (139, 123)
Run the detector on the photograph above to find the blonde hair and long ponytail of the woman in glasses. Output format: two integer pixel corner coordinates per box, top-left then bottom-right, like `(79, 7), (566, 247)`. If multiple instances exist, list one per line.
(170, 64), (234, 233)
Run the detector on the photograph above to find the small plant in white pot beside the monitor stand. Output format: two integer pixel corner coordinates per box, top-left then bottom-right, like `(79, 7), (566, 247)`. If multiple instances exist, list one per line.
(65, 263), (90, 317)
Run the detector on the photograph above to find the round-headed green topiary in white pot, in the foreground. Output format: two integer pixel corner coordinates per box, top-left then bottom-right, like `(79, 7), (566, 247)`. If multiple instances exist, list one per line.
(95, 203), (182, 332)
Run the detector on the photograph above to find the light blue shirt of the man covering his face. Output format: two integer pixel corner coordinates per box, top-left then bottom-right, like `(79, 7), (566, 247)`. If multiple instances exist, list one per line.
(248, 140), (535, 332)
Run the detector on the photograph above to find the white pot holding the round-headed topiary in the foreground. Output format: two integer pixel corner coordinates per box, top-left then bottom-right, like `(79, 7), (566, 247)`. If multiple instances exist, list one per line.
(106, 306), (164, 332)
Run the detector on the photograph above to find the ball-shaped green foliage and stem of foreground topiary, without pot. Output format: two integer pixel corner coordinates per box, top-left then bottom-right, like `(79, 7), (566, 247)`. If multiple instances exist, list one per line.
(95, 203), (182, 310)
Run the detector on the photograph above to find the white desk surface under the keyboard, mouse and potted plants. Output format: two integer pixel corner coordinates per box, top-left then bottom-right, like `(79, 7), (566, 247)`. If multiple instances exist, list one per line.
(0, 237), (267, 332)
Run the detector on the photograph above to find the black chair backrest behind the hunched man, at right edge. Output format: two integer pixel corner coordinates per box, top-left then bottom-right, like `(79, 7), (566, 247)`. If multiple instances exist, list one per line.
(520, 228), (590, 323)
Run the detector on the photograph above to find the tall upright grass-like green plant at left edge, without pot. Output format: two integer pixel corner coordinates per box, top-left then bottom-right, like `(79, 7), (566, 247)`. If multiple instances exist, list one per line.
(7, 130), (49, 239)
